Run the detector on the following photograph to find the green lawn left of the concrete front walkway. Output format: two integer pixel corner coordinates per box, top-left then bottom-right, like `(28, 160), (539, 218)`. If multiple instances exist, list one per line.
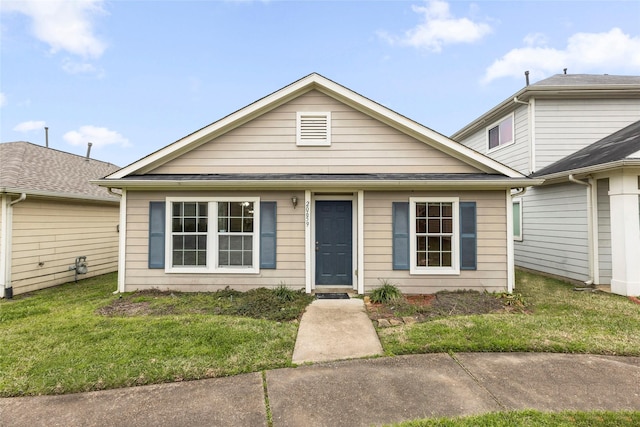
(0, 274), (308, 397)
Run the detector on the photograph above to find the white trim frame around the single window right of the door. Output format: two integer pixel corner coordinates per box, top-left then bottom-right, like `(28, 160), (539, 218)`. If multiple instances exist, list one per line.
(409, 197), (460, 275)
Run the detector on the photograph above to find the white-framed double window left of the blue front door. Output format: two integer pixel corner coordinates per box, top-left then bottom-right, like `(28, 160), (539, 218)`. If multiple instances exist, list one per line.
(165, 198), (260, 273)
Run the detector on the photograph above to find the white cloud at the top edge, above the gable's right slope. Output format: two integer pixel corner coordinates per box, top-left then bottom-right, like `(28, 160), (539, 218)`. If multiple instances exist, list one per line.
(378, 0), (492, 52)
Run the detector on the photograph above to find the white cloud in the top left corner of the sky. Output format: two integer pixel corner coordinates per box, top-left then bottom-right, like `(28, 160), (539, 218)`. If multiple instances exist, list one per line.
(2, 0), (106, 58)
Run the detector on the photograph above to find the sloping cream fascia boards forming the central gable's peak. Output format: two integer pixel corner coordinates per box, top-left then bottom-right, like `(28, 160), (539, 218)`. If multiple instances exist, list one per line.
(107, 73), (524, 179)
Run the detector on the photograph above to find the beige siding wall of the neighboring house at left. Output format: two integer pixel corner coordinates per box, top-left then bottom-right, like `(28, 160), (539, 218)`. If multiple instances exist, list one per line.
(11, 197), (118, 295)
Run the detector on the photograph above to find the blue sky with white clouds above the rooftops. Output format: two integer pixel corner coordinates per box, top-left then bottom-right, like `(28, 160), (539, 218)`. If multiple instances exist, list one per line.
(0, 0), (640, 166)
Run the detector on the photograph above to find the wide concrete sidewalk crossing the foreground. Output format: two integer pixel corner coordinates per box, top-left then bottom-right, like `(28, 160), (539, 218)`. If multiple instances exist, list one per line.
(0, 353), (640, 427)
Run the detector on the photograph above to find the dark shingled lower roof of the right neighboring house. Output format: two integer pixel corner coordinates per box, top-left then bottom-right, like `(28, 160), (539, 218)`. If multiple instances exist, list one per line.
(531, 121), (640, 177)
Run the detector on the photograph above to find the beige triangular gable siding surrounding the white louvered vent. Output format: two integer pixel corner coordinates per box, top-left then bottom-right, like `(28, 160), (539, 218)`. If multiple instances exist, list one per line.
(151, 91), (477, 174)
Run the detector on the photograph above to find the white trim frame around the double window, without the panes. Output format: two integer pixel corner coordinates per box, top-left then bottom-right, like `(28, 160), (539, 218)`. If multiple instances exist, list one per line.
(164, 197), (260, 274)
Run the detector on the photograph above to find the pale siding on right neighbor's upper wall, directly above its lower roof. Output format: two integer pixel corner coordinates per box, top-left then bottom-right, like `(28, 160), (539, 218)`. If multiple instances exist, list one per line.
(535, 99), (640, 170)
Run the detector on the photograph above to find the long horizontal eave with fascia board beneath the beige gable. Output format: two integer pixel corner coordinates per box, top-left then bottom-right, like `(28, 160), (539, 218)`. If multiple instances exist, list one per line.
(93, 178), (544, 191)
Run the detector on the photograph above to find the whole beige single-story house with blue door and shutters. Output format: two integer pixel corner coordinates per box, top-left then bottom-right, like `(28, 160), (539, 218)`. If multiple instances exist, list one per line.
(95, 74), (542, 293)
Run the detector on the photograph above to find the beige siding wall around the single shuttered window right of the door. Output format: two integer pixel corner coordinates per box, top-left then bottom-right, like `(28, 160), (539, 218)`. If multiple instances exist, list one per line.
(364, 191), (507, 294)
